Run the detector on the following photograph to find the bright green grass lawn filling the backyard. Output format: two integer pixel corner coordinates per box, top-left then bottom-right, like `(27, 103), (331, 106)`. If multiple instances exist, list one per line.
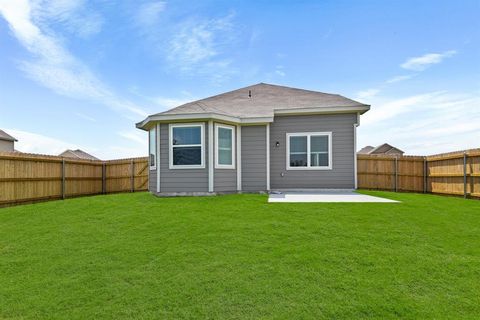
(0, 192), (480, 319)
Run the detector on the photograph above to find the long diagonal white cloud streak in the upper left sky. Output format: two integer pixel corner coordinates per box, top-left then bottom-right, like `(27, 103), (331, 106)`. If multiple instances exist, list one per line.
(0, 0), (147, 117)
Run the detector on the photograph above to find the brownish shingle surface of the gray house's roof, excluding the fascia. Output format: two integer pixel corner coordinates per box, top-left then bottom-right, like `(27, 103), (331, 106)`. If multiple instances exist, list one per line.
(157, 83), (368, 118)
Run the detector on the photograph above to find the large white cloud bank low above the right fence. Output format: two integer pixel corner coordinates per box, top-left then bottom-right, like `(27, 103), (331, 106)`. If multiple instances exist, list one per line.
(358, 92), (480, 155)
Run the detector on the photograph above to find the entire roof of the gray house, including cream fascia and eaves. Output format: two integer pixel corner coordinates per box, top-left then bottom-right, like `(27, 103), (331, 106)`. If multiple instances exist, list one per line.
(137, 83), (370, 129)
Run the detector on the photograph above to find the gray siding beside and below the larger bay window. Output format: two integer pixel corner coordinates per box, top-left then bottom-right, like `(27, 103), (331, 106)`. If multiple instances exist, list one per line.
(160, 123), (209, 193)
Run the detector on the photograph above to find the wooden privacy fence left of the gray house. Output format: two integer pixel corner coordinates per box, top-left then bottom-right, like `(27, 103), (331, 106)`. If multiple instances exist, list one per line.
(0, 153), (148, 206)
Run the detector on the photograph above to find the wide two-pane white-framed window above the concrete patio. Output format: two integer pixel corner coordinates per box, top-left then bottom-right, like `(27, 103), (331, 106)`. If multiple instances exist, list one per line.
(287, 132), (332, 170)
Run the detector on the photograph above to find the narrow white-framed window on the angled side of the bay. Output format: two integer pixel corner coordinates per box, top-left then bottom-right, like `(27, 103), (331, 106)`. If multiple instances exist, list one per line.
(215, 124), (235, 169)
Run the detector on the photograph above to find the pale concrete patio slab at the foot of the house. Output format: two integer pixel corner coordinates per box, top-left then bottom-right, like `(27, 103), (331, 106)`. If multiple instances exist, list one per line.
(268, 191), (399, 203)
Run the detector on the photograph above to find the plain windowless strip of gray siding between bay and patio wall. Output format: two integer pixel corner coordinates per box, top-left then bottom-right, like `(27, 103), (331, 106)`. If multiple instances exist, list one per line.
(242, 126), (267, 191)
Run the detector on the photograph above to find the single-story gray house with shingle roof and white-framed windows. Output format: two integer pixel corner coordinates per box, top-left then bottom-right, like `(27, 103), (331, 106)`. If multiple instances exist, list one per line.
(136, 83), (370, 195)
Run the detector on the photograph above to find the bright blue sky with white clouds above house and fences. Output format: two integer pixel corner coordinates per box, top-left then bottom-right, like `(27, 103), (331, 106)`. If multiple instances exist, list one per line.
(0, 0), (480, 159)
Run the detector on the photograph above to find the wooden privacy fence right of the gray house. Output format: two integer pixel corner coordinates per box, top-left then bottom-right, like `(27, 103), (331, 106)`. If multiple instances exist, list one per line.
(357, 149), (480, 197)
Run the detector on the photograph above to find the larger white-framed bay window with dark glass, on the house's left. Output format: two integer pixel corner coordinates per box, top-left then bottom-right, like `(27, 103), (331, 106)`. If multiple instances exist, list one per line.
(169, 123), (205, 169)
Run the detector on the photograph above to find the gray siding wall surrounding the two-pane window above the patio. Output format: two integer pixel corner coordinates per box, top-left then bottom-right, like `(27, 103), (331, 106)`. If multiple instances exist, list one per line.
(270, 114), (356, 189)
